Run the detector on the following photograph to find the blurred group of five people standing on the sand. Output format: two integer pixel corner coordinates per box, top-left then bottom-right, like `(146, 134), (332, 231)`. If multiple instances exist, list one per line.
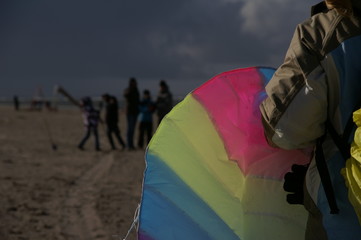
(78, 78), (173, 151)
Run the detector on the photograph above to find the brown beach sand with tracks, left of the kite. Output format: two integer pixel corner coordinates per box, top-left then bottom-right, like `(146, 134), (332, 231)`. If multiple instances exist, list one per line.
(0, 106), (145, 240)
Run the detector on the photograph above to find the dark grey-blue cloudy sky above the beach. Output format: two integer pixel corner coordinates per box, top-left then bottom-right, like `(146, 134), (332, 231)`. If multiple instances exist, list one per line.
(0, 0), (318, 98)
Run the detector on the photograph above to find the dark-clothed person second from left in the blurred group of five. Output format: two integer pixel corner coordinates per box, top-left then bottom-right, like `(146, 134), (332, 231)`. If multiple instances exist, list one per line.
(102, 94), (125, 149)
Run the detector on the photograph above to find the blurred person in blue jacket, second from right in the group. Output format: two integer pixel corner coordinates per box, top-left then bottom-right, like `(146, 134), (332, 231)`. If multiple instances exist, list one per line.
(138, 90), (155, 149)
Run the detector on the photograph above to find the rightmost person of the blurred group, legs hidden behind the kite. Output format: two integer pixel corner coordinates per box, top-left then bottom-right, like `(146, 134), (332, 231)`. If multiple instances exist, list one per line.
(156, 80), (173, 124)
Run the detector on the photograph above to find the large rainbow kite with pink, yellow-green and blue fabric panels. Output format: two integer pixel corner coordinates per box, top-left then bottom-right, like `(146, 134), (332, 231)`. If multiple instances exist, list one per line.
(138, 67), (309, 240)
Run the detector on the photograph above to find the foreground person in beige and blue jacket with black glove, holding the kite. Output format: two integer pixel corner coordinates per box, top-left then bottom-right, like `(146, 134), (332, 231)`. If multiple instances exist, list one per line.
(260, 0), (361, 240)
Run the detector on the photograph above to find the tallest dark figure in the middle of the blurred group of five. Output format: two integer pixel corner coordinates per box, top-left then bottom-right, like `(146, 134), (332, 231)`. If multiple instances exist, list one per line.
(124, 78), (139, 150)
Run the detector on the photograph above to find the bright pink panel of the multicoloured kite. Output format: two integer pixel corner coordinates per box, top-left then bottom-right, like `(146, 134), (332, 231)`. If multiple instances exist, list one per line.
(192, 67), (308, 179)
